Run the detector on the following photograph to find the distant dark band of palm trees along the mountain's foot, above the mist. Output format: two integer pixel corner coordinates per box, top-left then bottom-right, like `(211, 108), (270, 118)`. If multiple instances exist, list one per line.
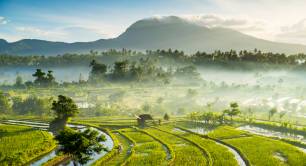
(0, 49), (306, 68)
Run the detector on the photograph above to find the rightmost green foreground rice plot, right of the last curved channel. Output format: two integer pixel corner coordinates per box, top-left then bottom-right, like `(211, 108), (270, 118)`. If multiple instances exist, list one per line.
(209, 127), (306, 166)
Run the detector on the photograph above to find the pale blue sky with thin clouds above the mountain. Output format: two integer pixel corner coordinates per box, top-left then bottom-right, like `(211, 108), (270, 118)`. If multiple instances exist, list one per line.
(0, 0), (306, 45)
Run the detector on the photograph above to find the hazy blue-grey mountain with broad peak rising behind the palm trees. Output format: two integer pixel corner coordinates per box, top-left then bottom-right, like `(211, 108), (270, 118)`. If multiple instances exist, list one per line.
(0, 16), (306, 55)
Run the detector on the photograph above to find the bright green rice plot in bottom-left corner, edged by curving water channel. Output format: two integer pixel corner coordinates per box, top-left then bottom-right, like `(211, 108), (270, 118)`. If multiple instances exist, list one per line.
(0, 124), (56, 165)
